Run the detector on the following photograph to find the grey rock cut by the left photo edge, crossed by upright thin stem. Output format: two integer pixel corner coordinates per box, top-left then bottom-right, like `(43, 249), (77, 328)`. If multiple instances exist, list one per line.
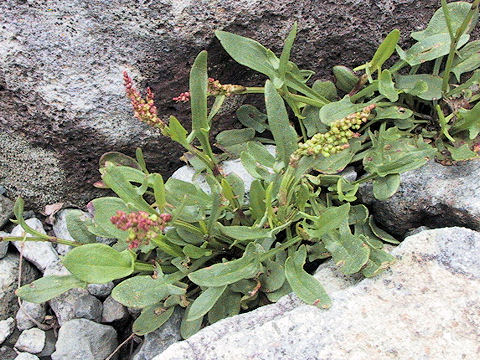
(0, 254), (38, 320)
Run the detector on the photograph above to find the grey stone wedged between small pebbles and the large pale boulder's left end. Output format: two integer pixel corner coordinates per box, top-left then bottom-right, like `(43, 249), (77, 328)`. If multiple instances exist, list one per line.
(132, 307), (183, 360)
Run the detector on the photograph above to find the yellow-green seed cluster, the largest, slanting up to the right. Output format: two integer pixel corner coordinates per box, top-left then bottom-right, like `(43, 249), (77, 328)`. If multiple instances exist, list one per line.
(294, 104), (375, 158)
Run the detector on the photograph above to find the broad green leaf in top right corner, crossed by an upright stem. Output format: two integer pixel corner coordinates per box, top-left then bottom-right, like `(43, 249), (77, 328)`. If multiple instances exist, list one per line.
(411, 1), (477, 41)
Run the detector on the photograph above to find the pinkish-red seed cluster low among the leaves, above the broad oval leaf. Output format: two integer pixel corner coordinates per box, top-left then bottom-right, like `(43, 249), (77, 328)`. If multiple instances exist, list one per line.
(110, 210), (172, 249)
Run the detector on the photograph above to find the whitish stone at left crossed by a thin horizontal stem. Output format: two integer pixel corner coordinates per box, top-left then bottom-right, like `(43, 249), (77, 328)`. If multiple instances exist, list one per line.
(12, 218), (59, 273)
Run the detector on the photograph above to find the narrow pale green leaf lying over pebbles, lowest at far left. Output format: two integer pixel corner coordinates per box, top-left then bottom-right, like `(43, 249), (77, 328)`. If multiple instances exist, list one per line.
(15, 275), (87, 304)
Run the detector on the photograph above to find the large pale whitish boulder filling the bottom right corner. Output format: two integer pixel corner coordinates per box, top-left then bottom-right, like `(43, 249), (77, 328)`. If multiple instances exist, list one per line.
(153, 227), (480, 360)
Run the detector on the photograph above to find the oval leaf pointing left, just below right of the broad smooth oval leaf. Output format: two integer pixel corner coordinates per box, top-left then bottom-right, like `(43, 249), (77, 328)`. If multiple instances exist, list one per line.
(112, 274), (185, 308)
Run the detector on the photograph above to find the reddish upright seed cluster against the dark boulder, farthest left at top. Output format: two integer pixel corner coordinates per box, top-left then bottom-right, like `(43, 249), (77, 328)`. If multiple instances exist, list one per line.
(123, 71), (166, 130)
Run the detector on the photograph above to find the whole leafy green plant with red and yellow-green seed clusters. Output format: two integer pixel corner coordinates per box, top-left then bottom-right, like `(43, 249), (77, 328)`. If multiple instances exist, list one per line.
(4, 0), (480, 338)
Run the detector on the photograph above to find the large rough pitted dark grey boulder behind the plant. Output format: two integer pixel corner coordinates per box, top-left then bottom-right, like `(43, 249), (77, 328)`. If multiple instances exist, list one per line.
(0, 0), (462, 209)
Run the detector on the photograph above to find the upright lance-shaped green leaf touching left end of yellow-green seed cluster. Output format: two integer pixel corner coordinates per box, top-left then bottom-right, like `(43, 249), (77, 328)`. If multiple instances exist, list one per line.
(265, 80), (298, 166)
